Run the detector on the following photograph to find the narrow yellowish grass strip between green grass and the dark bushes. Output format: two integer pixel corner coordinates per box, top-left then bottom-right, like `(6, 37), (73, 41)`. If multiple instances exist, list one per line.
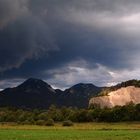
(0, 122), (140, 130)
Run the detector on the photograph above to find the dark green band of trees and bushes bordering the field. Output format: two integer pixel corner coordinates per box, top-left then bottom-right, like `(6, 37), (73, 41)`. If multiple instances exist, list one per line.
(0, 103), (140, 125)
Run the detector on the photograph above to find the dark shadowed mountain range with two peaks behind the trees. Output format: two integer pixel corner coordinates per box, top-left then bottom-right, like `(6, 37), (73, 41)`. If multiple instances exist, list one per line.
(0, 78), (102, 109)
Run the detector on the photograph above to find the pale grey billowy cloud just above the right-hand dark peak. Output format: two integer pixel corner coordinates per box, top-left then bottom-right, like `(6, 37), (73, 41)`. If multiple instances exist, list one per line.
(46, 60), (112, 88)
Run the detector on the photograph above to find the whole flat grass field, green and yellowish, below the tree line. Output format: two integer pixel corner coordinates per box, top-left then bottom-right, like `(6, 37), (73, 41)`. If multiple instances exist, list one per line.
(0, 122), (140, 140)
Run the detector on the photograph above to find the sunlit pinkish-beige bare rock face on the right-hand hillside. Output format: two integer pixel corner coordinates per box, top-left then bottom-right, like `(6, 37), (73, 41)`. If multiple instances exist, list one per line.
(89, 86), (140, 108)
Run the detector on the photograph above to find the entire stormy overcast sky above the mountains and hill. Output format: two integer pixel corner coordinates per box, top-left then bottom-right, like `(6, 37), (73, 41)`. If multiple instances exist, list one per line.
(0, 0), (140, 89)
